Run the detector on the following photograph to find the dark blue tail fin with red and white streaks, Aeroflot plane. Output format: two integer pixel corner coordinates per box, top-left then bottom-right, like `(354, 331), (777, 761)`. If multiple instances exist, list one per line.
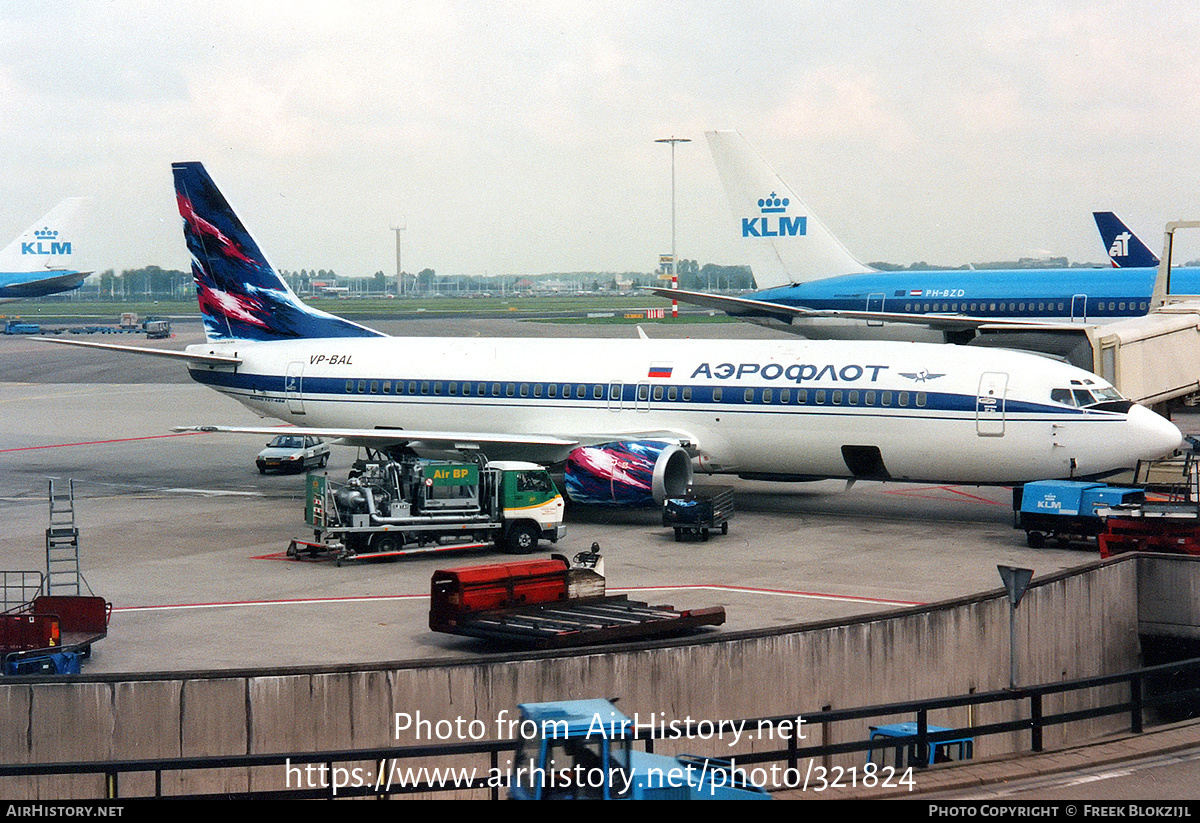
(172, 163), (380, 341)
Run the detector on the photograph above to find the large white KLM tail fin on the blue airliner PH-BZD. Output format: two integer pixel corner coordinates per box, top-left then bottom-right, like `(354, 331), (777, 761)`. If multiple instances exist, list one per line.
(706, 131), (875, 289)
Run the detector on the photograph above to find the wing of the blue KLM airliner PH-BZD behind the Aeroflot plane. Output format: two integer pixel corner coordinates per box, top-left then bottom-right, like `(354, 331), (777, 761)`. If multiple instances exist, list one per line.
(650, 288), (1079, 331)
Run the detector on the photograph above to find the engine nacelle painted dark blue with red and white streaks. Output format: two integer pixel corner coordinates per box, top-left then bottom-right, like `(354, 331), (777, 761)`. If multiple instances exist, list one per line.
(564, 440), (691, 506)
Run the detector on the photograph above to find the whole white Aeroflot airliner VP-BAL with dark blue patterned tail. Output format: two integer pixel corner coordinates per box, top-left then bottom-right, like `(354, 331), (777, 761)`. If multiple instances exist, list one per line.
(37, 163), (1181, 504)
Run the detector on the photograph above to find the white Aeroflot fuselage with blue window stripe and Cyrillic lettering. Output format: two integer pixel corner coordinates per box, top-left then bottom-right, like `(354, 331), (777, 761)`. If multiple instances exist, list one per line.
(187, 337), (1181, 483)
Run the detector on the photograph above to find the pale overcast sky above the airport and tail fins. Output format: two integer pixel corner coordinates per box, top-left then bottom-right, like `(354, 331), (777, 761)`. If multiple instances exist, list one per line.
(0, 0), (1200, 276)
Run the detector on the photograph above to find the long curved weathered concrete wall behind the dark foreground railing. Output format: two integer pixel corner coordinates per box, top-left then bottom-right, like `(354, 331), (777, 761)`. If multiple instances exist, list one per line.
(0, 557), (1156, 799)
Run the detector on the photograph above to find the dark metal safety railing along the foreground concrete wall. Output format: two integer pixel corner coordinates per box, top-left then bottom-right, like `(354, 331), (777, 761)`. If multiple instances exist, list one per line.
(7, 659), (1200, 799)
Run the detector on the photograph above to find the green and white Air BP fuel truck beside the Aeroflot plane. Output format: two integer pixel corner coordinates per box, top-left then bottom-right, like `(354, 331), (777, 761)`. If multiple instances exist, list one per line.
(297, 452), (565, 565)
